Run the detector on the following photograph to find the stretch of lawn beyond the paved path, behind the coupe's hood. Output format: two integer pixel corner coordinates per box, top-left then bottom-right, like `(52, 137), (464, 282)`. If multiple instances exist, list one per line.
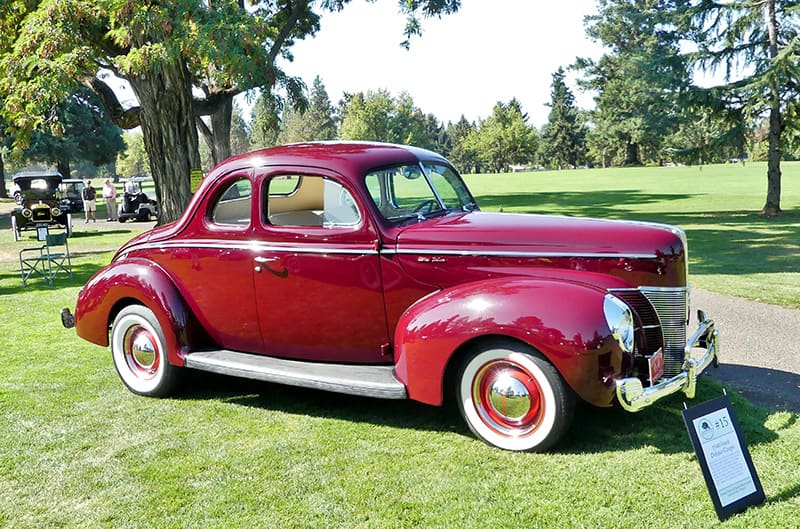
(466, 162), (800, 308)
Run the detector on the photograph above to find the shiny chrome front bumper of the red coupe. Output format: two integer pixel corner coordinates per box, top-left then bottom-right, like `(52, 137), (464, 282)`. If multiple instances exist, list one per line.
(617, 311), (719, 412)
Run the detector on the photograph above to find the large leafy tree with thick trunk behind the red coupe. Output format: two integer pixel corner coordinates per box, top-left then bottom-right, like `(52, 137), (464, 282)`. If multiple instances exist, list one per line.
(0, 0), (460, 222)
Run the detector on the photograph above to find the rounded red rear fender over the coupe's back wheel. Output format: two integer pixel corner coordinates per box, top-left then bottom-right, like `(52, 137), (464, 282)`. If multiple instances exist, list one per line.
(75, 258), (196, 365)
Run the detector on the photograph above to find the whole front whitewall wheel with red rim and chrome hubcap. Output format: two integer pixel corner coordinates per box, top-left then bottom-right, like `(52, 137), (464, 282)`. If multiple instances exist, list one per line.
(456, 341), (575, 452)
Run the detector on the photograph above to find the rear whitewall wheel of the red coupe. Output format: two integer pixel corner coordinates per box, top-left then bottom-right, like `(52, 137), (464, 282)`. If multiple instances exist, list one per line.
(111, 305), (180, 397)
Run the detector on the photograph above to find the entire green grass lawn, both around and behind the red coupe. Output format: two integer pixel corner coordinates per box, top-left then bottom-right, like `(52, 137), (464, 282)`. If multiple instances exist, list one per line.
(0, 166), (800, 529)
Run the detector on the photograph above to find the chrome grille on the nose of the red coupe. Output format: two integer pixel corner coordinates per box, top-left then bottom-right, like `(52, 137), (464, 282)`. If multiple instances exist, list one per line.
(611, 287), (689, 377)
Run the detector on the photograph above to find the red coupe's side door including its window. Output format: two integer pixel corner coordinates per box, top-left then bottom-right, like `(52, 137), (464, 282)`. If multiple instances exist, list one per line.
(253, 168), (391, 363)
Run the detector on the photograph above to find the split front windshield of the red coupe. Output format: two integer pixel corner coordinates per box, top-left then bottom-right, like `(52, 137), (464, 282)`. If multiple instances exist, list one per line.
(366, 162), (477, 221)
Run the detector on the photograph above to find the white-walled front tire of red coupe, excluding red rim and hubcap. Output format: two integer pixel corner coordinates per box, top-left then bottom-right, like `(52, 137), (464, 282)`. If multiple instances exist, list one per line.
(456, 348), (567, 451)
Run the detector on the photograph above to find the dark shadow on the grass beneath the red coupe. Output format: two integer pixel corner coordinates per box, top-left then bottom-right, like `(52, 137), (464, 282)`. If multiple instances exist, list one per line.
(177, 371), (777, 454)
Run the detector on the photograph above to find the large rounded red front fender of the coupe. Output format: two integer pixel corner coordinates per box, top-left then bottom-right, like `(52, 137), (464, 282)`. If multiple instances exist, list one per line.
(394, 277), (624, 406)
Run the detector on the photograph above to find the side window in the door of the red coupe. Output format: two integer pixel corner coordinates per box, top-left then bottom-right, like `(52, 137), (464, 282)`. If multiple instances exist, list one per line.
(266, 175), (361, 228)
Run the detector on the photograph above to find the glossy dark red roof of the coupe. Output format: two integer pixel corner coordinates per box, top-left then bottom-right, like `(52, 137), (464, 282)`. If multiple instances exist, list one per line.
(206, 141), (447, 186)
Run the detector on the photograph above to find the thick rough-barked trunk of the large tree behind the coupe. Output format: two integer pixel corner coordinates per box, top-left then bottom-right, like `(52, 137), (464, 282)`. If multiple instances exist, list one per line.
(130, 59), (200, 224)
